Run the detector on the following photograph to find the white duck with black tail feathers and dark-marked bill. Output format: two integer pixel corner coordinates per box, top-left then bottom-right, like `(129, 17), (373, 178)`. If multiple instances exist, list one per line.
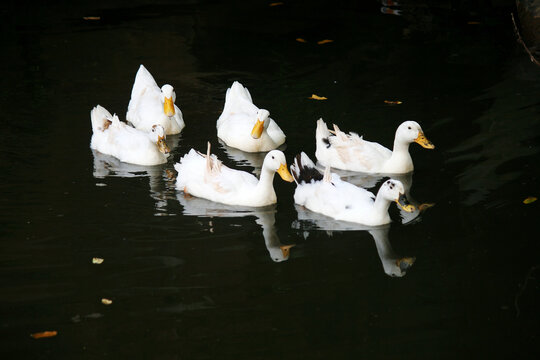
(291, 153), (414, 226)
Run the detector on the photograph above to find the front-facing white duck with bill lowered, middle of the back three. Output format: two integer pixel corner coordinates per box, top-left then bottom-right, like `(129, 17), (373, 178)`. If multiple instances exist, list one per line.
(216, 81), (285, 152)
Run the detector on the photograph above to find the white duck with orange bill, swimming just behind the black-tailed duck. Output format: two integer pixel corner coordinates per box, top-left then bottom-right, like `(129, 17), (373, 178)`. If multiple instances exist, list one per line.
(315, 119), (435, 174)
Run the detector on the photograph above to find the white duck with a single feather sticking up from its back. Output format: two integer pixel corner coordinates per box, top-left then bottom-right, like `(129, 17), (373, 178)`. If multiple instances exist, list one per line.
(174, 143), (293, 207)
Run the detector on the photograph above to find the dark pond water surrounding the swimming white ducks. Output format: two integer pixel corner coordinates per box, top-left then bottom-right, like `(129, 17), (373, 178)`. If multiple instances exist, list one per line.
(0, 1), (540, 359)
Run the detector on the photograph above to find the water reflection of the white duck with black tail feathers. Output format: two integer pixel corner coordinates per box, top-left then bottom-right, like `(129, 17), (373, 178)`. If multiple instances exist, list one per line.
(292, 205), (416, 277)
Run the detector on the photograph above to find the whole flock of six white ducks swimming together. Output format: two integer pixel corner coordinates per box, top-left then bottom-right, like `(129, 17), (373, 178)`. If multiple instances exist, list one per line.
(90, 65), (435, 235)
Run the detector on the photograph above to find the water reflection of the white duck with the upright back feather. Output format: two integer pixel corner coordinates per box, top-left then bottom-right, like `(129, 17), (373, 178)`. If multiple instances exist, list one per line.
(176, 192), (294, 262)
